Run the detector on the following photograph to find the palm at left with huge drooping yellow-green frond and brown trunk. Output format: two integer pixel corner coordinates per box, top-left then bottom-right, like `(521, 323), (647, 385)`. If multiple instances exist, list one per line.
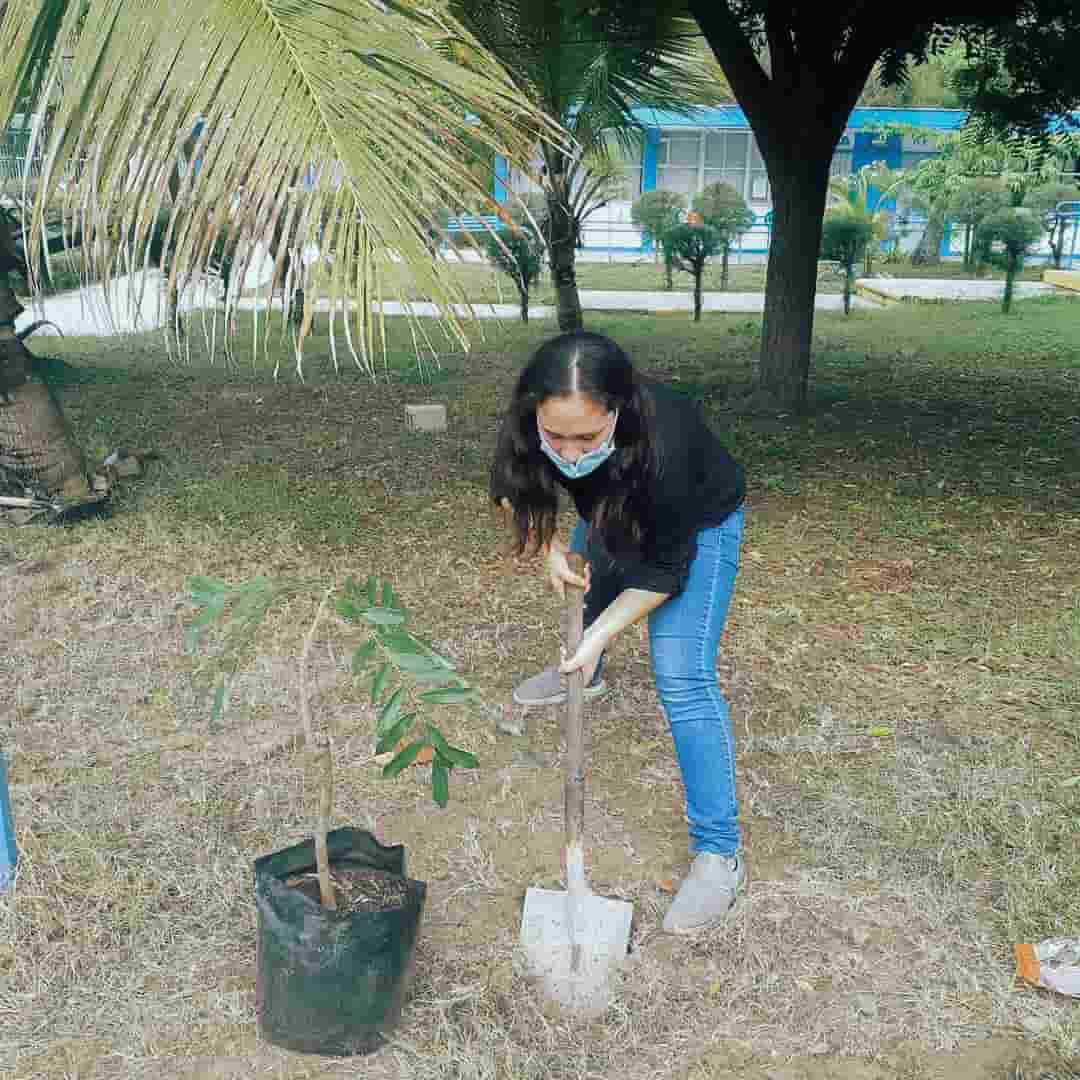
(0, 0), (544, 498)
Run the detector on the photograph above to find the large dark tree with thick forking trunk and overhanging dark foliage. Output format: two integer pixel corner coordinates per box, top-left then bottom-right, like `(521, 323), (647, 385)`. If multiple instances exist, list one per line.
(673, 0), (1080, 409)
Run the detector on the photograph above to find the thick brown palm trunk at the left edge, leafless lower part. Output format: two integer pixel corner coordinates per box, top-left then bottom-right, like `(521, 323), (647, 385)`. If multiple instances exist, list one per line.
(0, 273), (93, 499)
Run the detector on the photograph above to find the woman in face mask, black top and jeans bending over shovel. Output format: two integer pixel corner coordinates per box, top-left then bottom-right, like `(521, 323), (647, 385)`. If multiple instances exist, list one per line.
(491, 330), (745, 933)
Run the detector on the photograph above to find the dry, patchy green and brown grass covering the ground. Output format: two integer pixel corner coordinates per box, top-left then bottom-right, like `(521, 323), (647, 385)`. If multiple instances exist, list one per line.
(0, 305), (1080, 1080)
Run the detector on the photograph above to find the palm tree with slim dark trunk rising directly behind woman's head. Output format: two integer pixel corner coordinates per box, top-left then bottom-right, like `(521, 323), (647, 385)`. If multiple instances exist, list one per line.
(449, 0), (725, 330)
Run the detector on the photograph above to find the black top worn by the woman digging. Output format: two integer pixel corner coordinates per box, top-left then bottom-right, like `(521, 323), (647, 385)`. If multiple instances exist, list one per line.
(551, 379), (745, 595)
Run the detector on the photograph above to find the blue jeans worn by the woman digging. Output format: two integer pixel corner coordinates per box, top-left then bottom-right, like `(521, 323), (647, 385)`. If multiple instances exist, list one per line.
(570, 509), (743, 855)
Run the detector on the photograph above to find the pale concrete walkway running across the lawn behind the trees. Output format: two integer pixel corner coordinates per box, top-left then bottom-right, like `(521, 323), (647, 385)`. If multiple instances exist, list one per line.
(15, 270), (1066, 337)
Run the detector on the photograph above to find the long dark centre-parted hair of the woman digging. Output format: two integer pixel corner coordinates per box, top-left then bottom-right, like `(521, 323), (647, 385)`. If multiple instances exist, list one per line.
(490, 330), (657, 557)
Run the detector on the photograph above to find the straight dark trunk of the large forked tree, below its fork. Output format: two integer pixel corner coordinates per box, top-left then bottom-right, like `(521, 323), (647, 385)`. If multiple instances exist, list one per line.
(758, 156), (832, 411)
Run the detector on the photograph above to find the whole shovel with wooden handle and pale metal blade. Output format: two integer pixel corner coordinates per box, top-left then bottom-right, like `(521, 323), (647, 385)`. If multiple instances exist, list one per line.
(521, 555), (634, 1012)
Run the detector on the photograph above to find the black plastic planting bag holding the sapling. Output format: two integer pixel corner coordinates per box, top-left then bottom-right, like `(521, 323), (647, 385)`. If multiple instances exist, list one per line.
(255, 828), (428, 1055)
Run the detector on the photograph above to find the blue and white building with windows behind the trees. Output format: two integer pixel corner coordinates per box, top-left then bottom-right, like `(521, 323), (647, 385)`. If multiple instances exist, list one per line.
(495, 105), (1080, 260)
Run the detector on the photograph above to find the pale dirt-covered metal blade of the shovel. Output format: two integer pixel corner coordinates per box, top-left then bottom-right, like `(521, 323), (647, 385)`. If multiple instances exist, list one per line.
(521, 889), (634, 1012)
